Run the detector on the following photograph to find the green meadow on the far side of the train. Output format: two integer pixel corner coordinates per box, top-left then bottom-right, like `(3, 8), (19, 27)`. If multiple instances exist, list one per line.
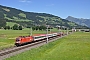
(0, 28), (58, 50)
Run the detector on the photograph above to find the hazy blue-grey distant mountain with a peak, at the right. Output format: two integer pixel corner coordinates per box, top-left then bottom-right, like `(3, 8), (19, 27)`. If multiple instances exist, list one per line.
(66, 16), (90, 28)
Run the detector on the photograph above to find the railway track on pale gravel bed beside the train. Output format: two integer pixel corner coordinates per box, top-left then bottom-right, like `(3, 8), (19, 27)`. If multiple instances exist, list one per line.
(0, 36), (64, 60)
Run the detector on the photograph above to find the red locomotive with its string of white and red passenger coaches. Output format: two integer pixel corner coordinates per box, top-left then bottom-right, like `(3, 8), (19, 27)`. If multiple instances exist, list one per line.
(15, 33), (62, 46)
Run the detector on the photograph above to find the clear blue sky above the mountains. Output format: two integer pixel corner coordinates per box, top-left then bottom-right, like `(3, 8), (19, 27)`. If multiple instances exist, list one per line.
(0, 0), (90, 19)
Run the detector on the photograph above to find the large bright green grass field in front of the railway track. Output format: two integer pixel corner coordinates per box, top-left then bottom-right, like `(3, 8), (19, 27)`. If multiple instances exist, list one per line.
(6, 32), (90, 60)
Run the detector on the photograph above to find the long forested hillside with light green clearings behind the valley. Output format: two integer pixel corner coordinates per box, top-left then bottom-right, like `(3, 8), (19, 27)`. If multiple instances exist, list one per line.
(0, 5), (87, 28)
